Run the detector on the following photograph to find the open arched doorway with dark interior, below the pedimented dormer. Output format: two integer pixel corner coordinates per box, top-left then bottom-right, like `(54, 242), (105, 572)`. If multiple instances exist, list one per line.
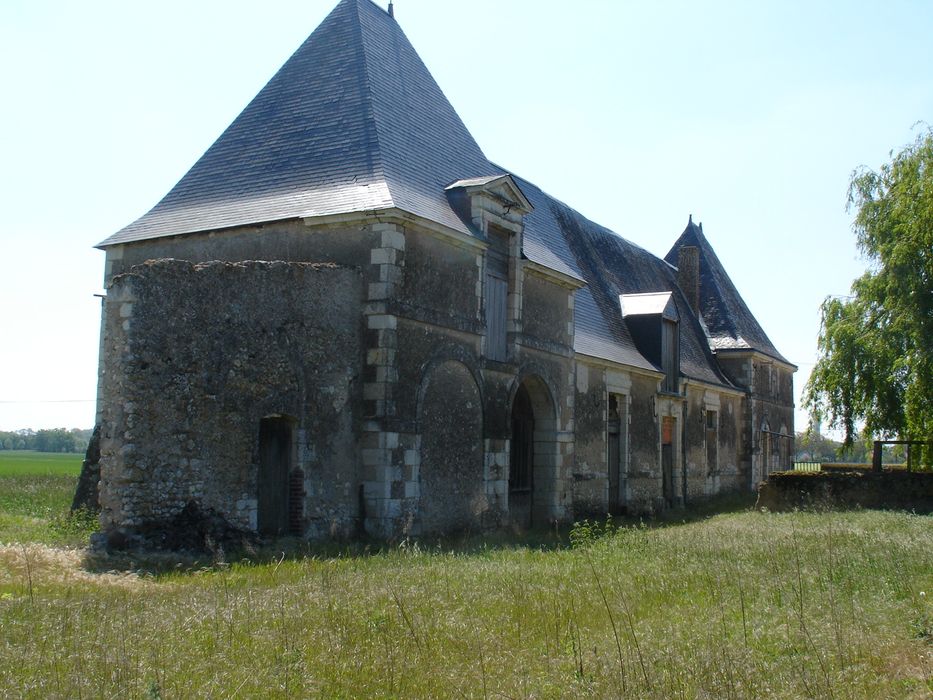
(508, 374), (561, 527)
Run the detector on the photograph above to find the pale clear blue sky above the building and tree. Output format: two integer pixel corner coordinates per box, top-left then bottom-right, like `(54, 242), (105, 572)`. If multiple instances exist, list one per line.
(0, 0), (933, 430)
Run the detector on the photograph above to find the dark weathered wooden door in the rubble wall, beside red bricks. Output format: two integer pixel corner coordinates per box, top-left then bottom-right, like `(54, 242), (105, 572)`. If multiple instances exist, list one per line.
(256, 418), (292, 535)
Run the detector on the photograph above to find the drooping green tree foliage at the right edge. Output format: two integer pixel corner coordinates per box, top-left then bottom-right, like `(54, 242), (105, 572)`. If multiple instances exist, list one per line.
(805, 128), (933, 446)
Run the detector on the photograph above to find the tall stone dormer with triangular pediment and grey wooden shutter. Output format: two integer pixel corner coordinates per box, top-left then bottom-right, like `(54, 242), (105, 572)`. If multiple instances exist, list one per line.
(446, 175), (533, 362)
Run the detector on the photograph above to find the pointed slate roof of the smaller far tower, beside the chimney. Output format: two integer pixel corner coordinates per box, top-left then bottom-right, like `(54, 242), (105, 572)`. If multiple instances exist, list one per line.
(664, 217), (790, 364)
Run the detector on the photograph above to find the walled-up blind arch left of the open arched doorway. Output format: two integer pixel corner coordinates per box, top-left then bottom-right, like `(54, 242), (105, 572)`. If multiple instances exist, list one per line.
(418, 359), (488, 534)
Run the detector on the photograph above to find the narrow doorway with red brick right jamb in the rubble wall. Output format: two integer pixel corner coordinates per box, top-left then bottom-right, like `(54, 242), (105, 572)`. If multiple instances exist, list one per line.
(256, 416), (304, 536)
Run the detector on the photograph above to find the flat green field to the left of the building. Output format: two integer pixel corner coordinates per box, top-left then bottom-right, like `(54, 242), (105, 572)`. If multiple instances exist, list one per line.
(0, 451), (89, 546)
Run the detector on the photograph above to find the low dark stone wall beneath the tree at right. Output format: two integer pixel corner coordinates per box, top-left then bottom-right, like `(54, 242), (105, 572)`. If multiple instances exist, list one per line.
(757, 470), (933, 514)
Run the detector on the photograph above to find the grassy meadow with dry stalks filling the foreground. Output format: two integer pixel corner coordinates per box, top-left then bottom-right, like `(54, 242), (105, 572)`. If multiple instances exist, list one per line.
(0, 452), (933, 698)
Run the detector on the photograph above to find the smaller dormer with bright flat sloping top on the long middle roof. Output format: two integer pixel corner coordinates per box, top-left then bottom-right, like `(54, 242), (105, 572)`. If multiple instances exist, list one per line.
(619, 292), (680, 394)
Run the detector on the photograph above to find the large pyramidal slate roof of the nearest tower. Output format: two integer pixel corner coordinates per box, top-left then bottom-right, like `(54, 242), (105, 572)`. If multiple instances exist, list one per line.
(100, 0), (503, 247)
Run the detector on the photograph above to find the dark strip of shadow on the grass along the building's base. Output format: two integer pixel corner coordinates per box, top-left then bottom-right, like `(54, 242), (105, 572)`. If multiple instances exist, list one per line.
(83, 493), (755, 577)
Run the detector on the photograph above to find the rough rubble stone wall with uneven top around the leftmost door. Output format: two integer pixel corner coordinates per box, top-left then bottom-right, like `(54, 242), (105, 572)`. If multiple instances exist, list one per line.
(100, 260), (363, 536)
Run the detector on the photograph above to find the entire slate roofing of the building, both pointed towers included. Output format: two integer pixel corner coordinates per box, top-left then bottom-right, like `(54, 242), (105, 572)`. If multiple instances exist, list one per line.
(99, 0), (783, 386)
